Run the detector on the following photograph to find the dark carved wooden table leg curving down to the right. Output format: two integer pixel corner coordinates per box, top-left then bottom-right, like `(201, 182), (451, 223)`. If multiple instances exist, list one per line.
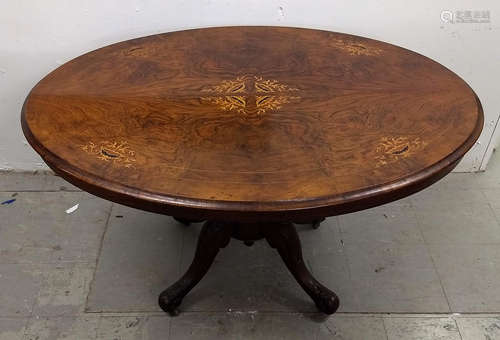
(262, 223), (339, 314)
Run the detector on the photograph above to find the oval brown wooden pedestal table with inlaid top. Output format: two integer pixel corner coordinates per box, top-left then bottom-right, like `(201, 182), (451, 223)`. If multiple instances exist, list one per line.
(22, 27), (483, 314)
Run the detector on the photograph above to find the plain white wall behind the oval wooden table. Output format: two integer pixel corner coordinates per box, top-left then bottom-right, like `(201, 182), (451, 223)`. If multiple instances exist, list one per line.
(0, 0), (500, 171)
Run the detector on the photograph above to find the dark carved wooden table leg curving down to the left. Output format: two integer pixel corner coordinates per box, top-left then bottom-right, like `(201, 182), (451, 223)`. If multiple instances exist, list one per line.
(158, 221), (231, 316)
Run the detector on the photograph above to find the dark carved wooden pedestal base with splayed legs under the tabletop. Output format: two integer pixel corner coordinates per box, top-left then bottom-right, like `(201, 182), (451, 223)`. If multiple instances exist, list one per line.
(158, 221), (339, 315)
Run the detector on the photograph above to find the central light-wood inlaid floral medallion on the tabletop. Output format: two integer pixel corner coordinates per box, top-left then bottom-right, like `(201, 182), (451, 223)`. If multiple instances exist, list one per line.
(201, 75), (300, 120)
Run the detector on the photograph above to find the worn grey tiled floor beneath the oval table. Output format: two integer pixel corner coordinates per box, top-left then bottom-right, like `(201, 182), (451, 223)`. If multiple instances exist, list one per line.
(0, 155), (500, 340)
